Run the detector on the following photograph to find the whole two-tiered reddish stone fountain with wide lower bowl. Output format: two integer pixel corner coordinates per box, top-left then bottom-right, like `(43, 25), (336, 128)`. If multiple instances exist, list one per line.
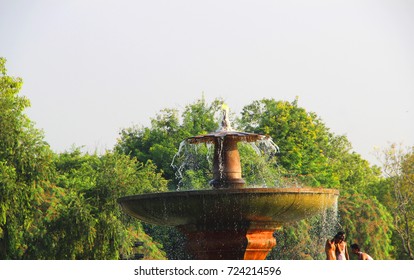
(118, 105), (339, 260)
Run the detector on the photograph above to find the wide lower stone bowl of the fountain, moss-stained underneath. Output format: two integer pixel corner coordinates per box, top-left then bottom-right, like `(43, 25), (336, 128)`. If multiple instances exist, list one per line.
(118, 187), (339, 226)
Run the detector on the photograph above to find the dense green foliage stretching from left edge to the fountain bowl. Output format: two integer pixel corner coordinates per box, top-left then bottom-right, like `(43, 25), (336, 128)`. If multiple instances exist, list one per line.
(0, 59), (167, 259)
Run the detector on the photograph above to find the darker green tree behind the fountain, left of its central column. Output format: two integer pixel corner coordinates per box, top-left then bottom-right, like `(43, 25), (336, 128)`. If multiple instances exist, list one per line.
(115, 98), (221, 190)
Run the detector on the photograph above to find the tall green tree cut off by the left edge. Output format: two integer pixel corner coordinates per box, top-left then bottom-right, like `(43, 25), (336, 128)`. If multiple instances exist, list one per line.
(0, 58), (53, 259)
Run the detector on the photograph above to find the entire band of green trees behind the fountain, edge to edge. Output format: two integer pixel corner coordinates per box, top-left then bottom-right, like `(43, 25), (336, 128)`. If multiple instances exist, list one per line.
(0, 58), (414, 259)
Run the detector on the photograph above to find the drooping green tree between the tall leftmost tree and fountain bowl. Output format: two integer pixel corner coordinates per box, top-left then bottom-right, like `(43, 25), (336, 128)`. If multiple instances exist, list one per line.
(29, 149), (167, 259)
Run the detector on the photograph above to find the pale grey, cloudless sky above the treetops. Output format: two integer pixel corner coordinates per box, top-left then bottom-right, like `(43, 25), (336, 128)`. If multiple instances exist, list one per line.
(0, 0), (414, 166)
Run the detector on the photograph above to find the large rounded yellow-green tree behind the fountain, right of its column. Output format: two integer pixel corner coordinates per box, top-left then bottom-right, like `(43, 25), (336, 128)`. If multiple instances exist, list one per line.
(238, 99), (380, 191)
